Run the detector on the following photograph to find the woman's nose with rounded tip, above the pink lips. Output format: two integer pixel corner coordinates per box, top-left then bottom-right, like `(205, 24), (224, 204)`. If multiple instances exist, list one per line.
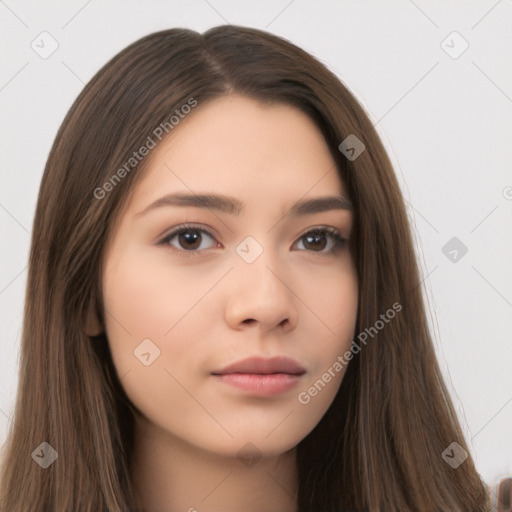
(225, 250), (298, 332)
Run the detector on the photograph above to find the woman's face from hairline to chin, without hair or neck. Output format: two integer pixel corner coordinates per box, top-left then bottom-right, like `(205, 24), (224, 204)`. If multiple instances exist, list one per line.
(102, 95), (358, 456)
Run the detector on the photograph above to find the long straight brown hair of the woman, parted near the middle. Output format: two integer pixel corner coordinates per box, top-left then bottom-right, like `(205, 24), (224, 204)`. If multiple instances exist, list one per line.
(0, 25), (490, 512)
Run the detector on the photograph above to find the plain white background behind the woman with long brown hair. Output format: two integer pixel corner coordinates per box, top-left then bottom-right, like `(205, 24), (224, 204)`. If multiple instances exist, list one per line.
(0, 0), (512, 484)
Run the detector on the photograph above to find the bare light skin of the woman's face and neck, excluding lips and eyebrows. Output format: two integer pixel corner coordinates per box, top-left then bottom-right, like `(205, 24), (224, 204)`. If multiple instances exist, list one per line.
(98, 94), (358, 512)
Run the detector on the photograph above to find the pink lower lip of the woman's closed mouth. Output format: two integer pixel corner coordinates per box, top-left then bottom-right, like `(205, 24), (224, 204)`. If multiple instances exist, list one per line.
(216, 373), (301, 396)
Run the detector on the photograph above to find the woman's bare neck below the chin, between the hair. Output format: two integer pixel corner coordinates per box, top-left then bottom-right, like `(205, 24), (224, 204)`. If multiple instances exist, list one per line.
(131, 419), (298, 512)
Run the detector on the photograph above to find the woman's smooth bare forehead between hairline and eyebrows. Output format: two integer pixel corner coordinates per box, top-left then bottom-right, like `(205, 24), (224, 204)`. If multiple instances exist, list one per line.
(127, 94), (346, 208)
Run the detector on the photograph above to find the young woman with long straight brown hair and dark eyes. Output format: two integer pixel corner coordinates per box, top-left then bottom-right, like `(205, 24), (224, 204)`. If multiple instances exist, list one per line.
(0, 26), (490, 512)
